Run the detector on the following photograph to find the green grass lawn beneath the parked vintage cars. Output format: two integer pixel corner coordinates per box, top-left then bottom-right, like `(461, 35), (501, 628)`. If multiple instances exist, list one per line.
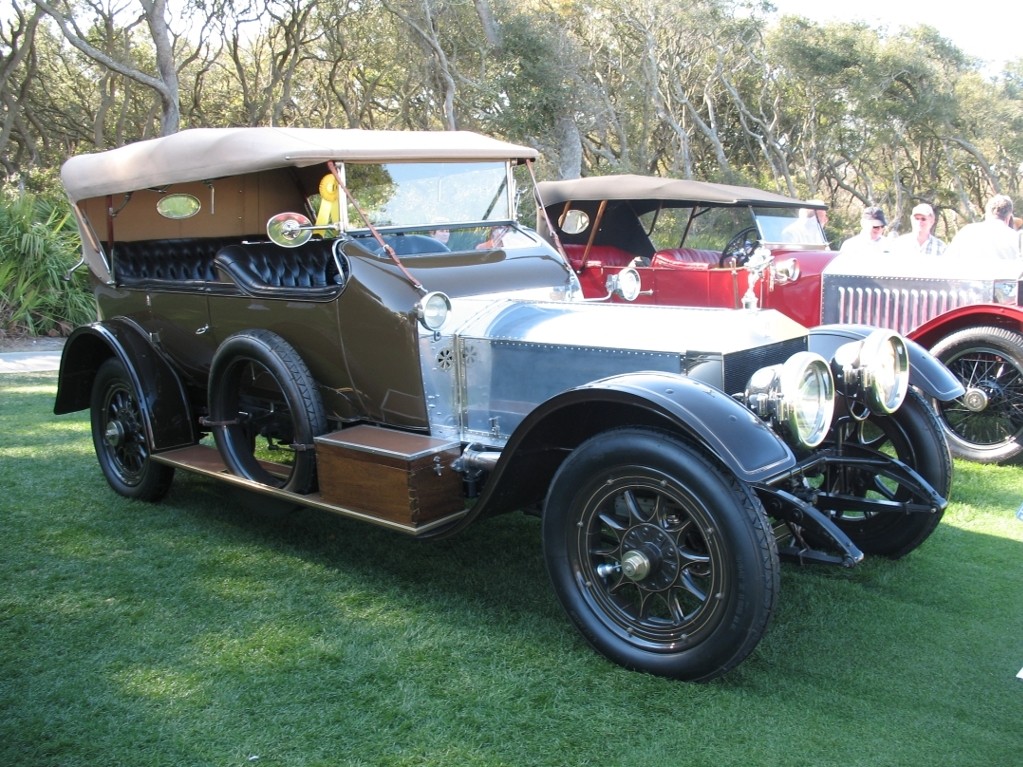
(0, 373), (1023, 767)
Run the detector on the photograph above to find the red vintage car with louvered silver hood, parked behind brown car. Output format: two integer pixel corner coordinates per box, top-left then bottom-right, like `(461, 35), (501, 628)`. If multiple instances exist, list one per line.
(537, 175), (1023, 463)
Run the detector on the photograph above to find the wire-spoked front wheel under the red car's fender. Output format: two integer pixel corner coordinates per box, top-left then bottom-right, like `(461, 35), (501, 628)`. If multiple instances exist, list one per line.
(931, 327), (1023, 463)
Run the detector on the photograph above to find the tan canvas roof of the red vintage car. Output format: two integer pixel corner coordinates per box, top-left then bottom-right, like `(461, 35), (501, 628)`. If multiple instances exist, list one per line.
(537, 174), (826, 209)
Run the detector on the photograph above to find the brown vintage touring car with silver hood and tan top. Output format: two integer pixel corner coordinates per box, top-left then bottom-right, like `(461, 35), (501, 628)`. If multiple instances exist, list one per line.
(54, 128), (958, 680)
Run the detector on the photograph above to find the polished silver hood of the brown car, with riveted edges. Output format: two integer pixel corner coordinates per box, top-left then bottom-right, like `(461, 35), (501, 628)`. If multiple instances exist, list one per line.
(420, 299), (806, 447)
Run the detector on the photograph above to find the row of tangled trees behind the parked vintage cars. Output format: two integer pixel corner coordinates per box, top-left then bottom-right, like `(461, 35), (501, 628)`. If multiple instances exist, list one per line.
(0, 0), (1023, 233)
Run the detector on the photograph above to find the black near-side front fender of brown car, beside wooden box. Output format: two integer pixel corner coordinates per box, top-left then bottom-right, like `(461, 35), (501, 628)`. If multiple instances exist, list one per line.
(474, 372), (796, 516)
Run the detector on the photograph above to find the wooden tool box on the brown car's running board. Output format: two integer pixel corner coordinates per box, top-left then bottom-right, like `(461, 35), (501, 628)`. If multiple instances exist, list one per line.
(316, 425), (464, 526)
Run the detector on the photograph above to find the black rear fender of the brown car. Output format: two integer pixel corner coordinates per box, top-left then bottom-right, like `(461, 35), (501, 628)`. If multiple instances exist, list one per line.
(53, 318), (197, 452)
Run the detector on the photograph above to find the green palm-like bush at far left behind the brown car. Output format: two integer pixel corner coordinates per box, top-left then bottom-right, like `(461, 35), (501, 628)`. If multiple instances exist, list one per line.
(0, 190), (95, 335)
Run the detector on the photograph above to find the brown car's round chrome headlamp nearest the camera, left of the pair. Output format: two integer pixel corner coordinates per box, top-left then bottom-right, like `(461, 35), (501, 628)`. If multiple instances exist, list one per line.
(746, 352), (835, 448)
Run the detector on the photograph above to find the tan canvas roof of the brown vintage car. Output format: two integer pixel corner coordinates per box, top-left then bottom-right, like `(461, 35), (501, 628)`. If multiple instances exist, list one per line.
(60, 128), (537, 201)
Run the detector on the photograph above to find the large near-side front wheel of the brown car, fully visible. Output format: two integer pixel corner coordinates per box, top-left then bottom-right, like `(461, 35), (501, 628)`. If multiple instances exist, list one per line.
(543, 428), (780, 681)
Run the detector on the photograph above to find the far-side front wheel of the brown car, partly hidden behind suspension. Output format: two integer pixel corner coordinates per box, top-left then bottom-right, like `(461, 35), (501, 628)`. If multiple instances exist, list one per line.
(826, 389), (952, 558)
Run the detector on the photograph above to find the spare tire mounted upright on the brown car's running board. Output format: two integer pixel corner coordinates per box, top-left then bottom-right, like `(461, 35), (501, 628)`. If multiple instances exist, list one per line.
(209, 330), (326, 494)
